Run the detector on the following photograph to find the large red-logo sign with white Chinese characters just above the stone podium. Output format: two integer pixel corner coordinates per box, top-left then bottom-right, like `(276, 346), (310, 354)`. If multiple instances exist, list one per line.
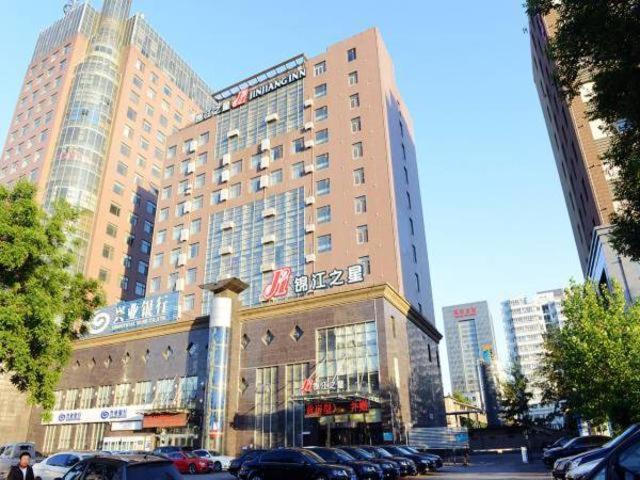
(262, 264), (364, 302)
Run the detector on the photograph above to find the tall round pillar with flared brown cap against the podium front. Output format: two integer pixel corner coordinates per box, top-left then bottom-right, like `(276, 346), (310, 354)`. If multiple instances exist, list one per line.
(200, 278), (249, 453)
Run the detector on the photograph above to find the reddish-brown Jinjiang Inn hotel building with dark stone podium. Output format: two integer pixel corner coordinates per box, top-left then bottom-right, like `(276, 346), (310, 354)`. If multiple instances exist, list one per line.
(23, 29), (446, 453)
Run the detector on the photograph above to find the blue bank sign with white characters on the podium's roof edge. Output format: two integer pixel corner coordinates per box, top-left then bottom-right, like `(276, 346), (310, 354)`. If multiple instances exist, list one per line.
(88, 292), (179, 336)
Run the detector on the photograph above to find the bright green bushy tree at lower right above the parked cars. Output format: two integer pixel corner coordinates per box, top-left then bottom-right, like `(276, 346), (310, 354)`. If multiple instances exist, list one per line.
(541, 282), (640, 429)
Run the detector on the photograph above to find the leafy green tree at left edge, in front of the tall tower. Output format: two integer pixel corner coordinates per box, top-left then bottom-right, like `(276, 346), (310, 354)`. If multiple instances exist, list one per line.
(0, 181), (103, 412)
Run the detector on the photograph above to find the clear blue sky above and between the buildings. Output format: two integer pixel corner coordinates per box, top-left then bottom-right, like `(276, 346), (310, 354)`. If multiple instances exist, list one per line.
(0, 0), (582, 394)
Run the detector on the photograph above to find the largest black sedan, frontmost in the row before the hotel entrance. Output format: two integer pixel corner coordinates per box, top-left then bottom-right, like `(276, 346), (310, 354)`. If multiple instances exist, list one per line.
(238, 448), (358, 480)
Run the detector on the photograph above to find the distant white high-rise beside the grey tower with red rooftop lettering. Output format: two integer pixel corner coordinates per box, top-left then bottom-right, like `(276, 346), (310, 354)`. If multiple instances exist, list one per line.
(502, 289), (565, 424)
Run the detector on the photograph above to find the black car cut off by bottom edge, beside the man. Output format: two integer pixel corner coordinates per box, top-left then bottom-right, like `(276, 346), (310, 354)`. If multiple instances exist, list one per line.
(49, 455), (182, 480)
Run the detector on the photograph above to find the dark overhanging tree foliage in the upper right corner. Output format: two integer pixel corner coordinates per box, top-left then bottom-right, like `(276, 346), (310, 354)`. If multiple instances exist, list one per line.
(526, 0), (640, 260)
